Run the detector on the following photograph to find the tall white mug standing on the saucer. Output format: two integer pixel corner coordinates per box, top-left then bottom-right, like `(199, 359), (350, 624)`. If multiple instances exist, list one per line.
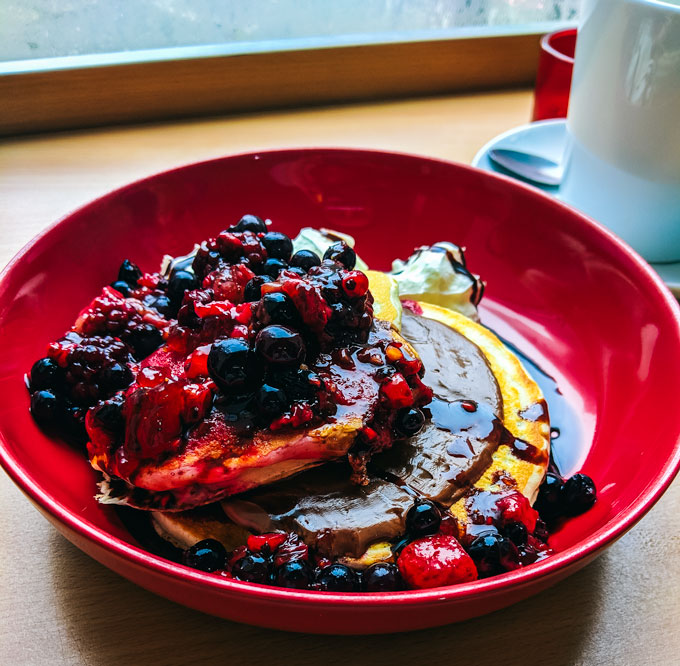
(560, 0), (680, 262)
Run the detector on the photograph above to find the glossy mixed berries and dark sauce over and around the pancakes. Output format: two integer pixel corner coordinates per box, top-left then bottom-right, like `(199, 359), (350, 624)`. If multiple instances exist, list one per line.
(27, 215), (596, 592)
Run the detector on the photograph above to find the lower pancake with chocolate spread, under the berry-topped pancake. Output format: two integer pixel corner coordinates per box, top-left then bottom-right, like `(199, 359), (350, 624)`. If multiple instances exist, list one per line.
(154, 303), (550, 568)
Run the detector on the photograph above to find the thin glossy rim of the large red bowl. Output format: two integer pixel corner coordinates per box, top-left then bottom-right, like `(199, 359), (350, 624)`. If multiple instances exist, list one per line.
(0, 148), (680, 607)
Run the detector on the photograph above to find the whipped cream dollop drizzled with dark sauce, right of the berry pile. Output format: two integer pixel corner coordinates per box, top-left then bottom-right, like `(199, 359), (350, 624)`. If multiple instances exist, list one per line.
(391, 243), (484, 321)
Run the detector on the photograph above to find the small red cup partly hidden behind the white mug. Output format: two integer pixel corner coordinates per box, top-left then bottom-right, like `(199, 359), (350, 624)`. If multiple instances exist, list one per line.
(531, 28), (576, 120)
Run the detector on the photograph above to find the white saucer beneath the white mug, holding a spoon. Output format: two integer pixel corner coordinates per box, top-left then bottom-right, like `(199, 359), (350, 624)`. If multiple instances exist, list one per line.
(472, 118), (680, 298)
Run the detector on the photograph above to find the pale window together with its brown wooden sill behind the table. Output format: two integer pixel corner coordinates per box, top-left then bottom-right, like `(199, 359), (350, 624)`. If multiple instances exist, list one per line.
(0, 0), (579, 135)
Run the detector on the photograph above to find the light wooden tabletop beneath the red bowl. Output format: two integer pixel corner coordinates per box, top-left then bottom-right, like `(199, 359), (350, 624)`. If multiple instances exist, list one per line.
(0, 92), (680, 666)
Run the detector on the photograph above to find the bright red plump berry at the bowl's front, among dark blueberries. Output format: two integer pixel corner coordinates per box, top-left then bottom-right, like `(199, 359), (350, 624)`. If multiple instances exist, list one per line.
(397, 534), (477, 589)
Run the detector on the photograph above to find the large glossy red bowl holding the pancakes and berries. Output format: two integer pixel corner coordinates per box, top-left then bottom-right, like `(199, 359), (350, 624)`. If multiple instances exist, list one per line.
(0, 149), (680, 633)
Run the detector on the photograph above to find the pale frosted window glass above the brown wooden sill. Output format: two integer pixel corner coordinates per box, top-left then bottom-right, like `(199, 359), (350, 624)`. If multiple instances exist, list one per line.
(0, 0), (580, 61)
